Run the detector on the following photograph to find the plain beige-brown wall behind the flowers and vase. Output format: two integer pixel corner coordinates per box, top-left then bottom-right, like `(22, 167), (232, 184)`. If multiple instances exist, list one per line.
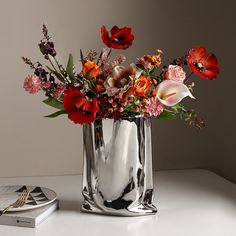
(0, 0), (236, 181)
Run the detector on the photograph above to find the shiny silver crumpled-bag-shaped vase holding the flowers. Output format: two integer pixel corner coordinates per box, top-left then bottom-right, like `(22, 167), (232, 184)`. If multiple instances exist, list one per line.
(81, 116), (157, 216)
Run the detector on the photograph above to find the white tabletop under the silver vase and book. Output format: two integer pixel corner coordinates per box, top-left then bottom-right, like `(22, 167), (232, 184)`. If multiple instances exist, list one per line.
(0, 170), (236, 236)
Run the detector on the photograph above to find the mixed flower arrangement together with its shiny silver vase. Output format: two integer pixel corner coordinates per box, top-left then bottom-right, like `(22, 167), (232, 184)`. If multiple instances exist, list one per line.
(22, 25), (219, 216)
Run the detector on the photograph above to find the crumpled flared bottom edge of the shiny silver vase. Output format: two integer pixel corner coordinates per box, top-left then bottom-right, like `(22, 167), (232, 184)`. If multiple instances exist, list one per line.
(81, 201), (157, 216)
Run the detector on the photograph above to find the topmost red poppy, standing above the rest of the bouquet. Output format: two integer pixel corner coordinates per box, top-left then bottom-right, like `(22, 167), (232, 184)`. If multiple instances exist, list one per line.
(101, 26), (134, 49)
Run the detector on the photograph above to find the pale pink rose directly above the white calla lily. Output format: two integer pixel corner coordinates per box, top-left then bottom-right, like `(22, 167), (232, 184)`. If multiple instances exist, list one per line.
(164, 65), (186, 83)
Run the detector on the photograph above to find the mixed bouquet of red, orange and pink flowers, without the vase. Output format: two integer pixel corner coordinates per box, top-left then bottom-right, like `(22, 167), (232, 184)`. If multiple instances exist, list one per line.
(22, 25), (219, 127)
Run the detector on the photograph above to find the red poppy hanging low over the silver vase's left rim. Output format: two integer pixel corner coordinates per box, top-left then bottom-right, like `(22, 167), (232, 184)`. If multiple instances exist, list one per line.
(63, 88), (98, 124)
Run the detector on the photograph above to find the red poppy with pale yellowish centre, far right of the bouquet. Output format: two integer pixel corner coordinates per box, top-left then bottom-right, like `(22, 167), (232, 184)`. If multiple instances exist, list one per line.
(188, 46), (219, 80)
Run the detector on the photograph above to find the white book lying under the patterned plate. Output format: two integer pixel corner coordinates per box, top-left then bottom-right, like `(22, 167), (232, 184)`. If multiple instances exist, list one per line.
(0, 200), (59, 228)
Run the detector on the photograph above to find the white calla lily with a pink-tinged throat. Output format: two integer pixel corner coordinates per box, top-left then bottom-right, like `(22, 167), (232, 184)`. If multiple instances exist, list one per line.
(156, 80), (195, 107)
